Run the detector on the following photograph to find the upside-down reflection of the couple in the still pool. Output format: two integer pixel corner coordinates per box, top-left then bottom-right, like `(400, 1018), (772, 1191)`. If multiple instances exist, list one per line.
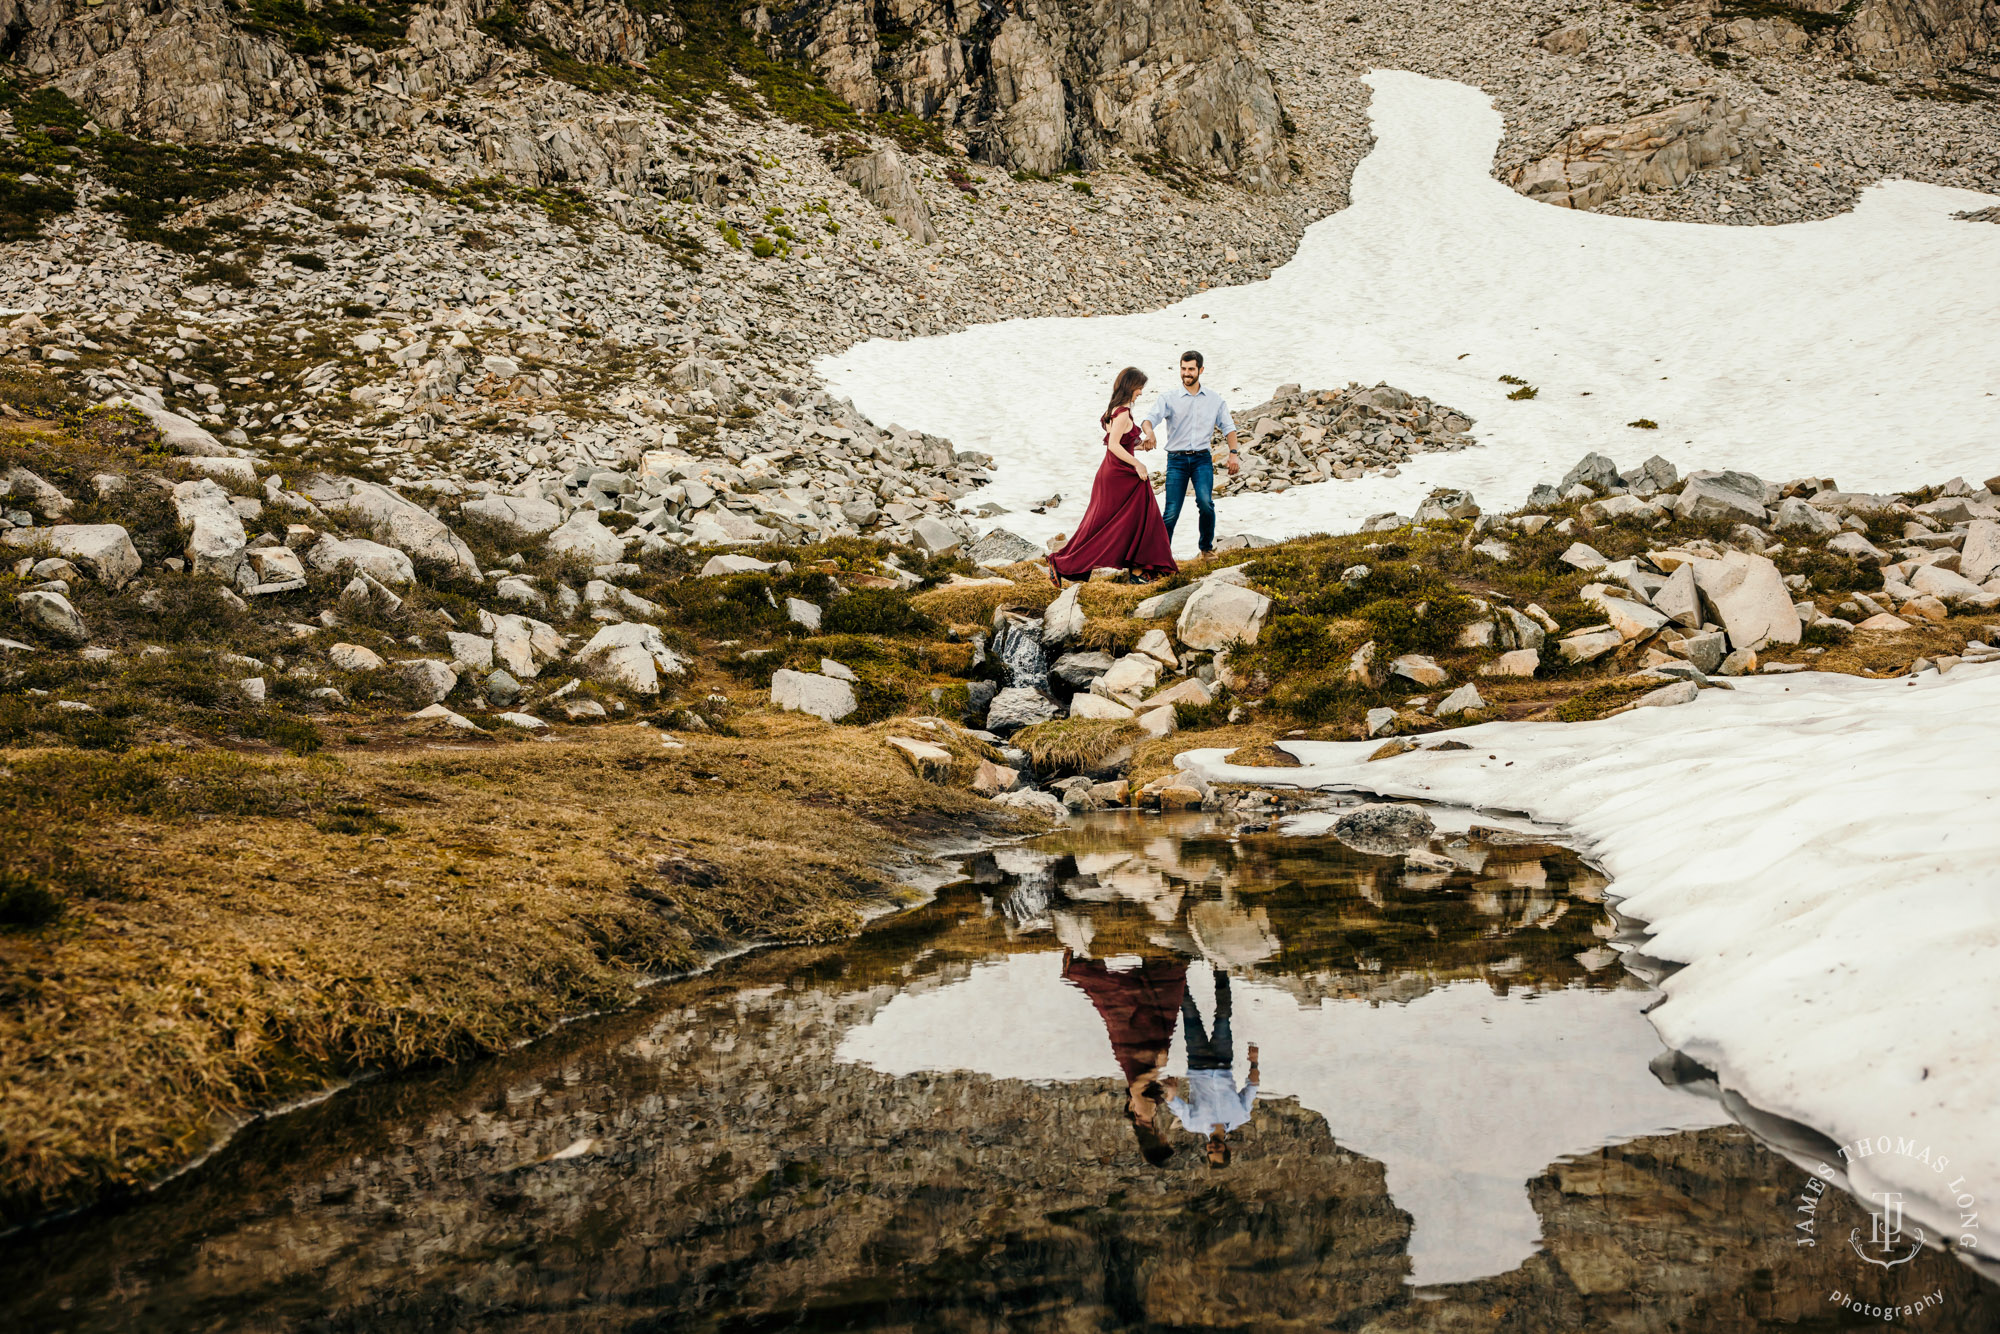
(1062, 948), (1260, 1168)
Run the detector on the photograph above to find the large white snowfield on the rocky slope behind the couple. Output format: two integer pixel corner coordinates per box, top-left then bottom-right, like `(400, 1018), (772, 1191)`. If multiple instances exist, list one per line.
(818, 72), (2000, 554)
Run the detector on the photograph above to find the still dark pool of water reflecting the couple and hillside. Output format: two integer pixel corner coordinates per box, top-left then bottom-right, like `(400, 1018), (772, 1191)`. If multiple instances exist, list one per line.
(0, 816), (2000, 1332)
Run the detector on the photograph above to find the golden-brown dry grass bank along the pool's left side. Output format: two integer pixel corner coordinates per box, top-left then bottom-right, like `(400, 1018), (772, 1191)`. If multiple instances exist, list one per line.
(0, 716), (1010, 1220)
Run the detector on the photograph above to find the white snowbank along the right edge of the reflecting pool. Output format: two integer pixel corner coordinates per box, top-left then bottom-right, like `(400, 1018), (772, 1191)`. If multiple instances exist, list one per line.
(1182, 666), (2000, 1252)
